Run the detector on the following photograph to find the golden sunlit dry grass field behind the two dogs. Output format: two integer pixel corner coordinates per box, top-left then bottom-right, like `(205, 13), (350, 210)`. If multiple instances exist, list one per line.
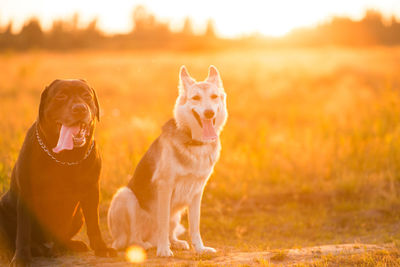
(0, 47), (400, 266)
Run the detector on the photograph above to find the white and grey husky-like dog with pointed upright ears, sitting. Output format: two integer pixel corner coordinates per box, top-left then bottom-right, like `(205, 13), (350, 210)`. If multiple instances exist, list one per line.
(108, 66), (227, 256)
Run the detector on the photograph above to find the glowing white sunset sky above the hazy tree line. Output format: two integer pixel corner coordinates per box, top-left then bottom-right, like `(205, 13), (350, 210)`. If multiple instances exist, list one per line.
(0, 0), (400, 37)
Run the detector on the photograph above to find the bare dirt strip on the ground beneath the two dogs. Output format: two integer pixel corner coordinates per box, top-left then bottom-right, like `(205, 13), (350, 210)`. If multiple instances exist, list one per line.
(0, 244), (388, 267)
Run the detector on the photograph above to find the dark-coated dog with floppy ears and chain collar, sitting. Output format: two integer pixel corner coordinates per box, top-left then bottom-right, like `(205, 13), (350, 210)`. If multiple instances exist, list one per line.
(0, 80), (116, 266)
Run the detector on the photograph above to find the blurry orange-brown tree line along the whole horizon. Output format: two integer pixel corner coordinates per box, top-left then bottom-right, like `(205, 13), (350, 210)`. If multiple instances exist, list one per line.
(0, 6), (400, 50)
